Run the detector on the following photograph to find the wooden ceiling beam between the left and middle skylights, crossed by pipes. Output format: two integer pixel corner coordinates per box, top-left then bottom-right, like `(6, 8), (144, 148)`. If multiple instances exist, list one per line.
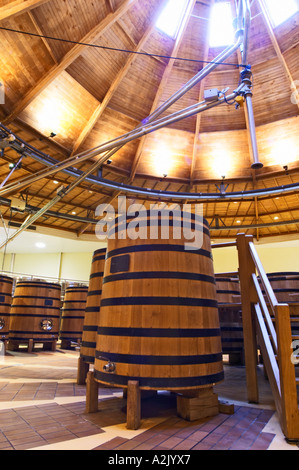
(130, 0), (196, 183)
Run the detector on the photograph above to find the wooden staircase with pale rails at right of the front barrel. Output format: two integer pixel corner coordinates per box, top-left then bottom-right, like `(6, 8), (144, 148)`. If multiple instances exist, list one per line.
(213, 234), (299, 442)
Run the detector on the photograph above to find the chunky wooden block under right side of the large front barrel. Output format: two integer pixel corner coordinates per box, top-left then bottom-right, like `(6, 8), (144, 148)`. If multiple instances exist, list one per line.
(177, 388), (219, 421)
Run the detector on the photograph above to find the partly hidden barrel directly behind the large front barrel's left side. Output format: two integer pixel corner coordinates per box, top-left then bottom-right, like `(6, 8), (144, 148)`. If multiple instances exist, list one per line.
(80, 248), (106, 364)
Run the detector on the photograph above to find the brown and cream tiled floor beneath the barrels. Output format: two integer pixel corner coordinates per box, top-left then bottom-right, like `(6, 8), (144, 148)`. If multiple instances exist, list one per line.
(0, 348), (299, 452)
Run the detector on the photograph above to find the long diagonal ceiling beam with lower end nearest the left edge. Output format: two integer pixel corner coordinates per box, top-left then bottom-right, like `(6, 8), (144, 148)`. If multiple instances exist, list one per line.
(4, 0), (138, 124)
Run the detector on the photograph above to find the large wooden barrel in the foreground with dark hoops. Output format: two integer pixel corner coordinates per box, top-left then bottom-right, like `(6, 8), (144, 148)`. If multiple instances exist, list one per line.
(94, 211), (223, 392)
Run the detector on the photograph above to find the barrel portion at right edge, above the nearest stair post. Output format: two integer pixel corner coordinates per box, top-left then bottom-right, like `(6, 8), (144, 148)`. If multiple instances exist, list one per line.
(267, 271), (299, 303)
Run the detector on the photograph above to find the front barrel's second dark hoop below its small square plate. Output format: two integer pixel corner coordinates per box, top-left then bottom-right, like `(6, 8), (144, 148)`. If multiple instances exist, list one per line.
(101, 296), (218, 308)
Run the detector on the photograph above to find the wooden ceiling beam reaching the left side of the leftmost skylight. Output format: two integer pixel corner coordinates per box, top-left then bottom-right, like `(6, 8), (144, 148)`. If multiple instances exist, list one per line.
(72, 0), (166, 155)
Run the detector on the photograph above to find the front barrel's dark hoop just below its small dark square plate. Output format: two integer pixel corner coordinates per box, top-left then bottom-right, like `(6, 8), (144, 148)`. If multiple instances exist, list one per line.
(103, 271), (215, 284)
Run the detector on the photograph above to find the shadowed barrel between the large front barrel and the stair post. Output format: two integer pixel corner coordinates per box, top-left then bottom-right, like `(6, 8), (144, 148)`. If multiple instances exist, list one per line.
(215, 273), (244, 363)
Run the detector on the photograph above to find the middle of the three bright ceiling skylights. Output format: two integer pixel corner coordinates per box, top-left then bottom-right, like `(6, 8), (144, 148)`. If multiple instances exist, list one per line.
(209, 2), (235, 47)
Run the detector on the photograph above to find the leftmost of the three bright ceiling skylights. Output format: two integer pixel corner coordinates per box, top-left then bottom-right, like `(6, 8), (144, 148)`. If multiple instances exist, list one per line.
(156, 0), (188, 38)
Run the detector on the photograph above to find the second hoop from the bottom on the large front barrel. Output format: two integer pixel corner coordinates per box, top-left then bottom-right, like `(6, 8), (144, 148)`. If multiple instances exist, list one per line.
(95, 351), (222, 366)
